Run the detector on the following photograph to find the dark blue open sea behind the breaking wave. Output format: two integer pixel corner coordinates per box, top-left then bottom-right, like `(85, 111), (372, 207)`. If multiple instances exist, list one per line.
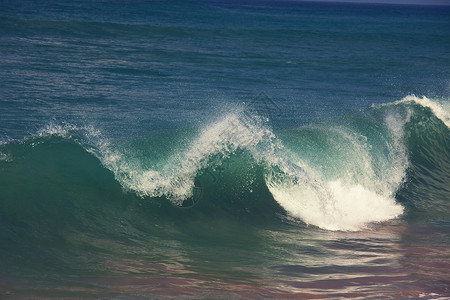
(1, 1), (450, 138)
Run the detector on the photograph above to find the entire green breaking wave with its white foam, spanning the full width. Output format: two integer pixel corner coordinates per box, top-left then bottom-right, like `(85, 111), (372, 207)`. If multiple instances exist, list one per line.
(0, 96), (450, 231)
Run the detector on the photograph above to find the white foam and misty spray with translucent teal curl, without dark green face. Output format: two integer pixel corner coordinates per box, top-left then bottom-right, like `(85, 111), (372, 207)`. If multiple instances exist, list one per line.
(14, 100), (442, 230)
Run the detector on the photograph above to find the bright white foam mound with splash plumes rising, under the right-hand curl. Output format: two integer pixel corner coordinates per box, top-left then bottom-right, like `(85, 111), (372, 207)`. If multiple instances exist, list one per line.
(266, 113), (409, 231)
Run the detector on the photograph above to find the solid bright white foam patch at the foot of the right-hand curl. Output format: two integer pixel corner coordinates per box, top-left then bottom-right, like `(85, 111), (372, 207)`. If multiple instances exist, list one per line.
(268, 178), (403, 231)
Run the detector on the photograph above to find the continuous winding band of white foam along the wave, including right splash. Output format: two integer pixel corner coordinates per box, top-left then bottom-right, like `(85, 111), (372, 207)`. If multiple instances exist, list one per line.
(31, 100), (432, 230)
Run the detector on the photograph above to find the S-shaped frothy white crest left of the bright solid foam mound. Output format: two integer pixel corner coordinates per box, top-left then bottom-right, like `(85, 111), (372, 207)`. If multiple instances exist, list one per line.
(97, 113), (277, 205)
